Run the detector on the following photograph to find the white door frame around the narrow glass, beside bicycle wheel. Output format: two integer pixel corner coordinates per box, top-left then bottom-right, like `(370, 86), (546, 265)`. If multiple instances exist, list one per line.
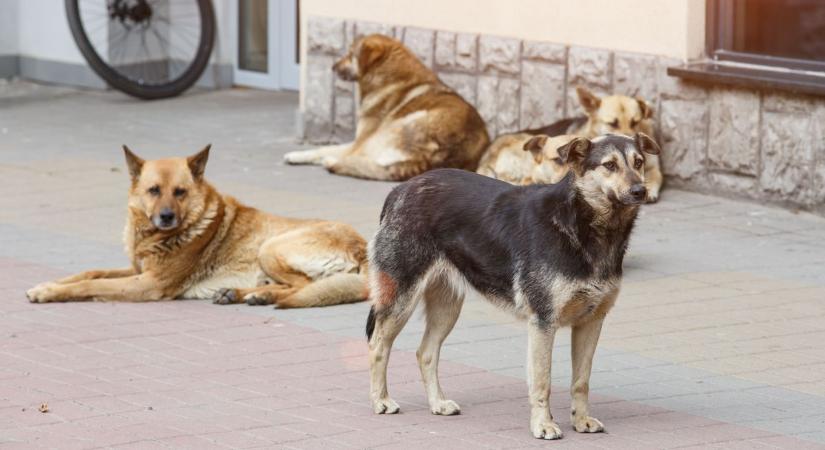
(229, 0), (300, 91)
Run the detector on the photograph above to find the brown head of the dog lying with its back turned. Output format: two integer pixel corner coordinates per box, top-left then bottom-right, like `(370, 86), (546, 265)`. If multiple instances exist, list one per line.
(332, 34), (429, 87)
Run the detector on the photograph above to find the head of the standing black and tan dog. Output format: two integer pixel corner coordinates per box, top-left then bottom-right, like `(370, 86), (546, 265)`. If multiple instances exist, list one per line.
(558, 133), (659, 205)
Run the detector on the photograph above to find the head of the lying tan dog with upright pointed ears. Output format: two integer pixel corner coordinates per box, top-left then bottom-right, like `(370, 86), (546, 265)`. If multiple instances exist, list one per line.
(123, 145), (211, 231)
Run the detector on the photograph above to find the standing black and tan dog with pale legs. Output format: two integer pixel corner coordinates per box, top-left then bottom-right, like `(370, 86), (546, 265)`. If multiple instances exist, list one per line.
(367, 133), (659, 439)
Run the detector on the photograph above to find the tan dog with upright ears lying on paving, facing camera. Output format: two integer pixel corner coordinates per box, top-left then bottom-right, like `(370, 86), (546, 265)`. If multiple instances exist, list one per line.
(26, 146), (367, 308)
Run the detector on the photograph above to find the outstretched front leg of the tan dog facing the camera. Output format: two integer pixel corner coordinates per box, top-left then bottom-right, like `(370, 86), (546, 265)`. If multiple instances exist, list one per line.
(26, 273), (164, 303)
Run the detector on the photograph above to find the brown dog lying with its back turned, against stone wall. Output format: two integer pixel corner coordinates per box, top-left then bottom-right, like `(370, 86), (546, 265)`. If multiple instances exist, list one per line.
(284, 34), (490, 180)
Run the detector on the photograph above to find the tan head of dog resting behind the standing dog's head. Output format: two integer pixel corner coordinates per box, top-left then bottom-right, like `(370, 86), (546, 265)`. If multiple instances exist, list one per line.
(576, 86), (653, 138)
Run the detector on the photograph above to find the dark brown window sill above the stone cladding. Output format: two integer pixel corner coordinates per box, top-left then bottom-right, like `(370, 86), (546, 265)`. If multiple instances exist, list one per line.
(667, 60), (825, 96)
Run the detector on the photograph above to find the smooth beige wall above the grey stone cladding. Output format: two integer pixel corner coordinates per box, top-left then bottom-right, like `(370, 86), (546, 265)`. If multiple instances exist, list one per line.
(301, 0), (705, 106)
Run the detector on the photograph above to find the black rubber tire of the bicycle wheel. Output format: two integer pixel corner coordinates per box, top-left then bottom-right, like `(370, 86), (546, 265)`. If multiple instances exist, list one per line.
(65, 0), (215, 100)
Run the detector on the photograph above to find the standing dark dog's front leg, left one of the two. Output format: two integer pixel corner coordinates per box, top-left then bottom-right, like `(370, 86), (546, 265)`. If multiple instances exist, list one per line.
(527, 318), (562, 439)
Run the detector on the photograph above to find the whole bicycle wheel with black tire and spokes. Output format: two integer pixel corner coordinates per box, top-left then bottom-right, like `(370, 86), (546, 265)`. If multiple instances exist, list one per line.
(65, 0), (215, 99)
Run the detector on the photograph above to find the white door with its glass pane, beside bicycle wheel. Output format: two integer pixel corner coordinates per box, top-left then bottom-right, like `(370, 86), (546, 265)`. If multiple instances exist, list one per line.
(230, 0), (300, 90)
